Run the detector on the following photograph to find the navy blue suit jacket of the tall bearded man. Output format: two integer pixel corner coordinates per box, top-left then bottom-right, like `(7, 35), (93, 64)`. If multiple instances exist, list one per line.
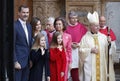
(14, 20), (32, 68)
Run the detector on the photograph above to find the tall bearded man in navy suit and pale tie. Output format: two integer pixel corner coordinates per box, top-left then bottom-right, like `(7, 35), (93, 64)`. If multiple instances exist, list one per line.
(14, 5), (32, 81)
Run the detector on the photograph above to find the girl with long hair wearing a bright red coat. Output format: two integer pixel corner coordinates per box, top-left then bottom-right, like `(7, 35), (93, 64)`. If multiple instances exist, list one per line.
(50, 32), (66, 81)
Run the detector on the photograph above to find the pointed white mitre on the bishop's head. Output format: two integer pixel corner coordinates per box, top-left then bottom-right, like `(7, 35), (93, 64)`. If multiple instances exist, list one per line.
(87, 11), (99, 25)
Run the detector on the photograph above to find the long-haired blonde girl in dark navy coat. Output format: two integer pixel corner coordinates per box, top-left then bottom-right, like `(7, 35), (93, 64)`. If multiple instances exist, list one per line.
(29, 33), (50, 81)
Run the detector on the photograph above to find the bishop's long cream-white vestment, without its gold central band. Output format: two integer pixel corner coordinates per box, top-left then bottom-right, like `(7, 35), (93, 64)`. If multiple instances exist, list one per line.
(79, 31), (115, 81)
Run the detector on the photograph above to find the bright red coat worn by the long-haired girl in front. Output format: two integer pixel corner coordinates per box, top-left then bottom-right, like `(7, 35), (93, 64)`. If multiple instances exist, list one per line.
(50, 48), (66, 81)
